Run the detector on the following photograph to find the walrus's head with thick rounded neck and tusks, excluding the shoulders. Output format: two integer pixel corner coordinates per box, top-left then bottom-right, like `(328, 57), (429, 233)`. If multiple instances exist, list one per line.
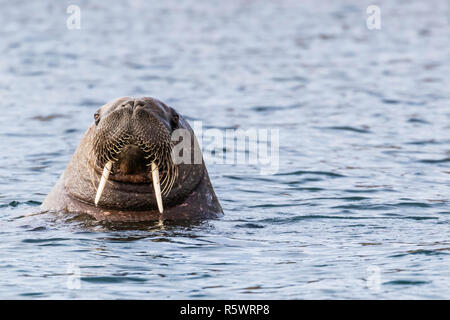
(60, 97), (205, 213)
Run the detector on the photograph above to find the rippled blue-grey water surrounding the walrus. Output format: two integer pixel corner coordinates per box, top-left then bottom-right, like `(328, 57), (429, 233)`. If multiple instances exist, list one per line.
(0, 0), (450, 299)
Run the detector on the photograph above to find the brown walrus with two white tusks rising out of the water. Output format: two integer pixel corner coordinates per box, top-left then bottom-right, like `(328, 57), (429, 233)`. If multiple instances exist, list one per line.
(41, 97), (223, 222)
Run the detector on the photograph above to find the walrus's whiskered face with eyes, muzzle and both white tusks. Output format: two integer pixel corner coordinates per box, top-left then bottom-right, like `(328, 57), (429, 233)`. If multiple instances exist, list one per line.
(90, 97), (179, 213)
